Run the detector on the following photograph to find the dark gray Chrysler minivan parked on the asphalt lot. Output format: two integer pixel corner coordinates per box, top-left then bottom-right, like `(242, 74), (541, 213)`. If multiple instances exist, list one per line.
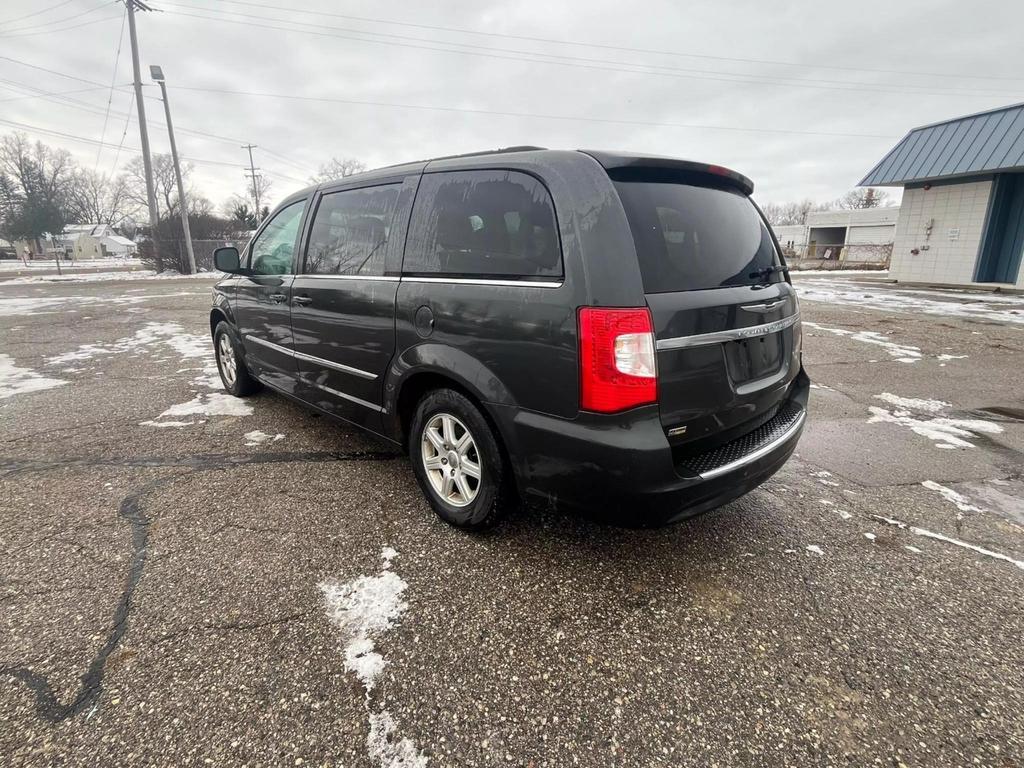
(210, 147), (809, 528)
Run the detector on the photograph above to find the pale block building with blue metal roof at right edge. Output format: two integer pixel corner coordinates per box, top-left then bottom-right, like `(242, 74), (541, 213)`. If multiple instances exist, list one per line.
(860, 104), (1024, 288)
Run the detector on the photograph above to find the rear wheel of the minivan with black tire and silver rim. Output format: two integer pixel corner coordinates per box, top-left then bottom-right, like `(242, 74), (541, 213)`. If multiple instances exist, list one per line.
(409, 389), (513, 530)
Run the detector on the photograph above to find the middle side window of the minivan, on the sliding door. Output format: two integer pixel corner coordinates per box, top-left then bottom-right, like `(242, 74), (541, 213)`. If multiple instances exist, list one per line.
(305, 184), (401, 275)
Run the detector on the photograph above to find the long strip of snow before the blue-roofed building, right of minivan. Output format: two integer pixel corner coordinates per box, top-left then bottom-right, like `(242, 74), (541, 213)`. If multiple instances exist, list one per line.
(796, 279), (1024, 325)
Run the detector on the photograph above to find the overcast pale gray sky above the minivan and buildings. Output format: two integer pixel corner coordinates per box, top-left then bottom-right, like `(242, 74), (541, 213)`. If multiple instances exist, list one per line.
(0, 0), (1024, 214)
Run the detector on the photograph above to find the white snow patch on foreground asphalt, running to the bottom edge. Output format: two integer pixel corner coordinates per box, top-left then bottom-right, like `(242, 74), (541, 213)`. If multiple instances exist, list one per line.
(319, 547), (427, 768)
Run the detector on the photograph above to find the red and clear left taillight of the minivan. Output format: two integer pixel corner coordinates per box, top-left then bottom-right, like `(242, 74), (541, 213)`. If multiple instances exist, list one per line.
(580, 307), (657, 414)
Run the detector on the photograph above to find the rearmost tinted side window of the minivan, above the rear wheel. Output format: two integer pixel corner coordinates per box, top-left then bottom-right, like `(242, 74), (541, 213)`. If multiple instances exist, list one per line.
(402, 171), (562, 279)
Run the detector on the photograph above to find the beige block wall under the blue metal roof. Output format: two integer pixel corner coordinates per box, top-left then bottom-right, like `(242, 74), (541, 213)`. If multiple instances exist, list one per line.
(889, 181), (992, 285)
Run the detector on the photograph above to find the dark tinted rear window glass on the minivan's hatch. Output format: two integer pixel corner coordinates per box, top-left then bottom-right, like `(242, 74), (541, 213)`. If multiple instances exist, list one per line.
(614, 180), (782, 293)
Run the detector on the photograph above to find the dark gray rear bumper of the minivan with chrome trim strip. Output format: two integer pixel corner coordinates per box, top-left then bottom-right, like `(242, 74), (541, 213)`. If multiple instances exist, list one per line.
(496, 371), (809, 526)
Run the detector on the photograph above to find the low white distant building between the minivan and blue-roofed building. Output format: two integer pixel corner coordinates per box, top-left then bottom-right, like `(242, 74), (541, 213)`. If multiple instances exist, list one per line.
(772, 206), (900, 264)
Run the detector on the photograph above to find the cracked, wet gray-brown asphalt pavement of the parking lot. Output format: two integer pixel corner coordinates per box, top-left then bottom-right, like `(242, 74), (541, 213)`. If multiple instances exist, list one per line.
(0, 275), (1024, 768)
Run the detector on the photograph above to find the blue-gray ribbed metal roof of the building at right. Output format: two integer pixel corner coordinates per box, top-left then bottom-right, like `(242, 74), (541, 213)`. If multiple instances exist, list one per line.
(859, 103), (1024, 186)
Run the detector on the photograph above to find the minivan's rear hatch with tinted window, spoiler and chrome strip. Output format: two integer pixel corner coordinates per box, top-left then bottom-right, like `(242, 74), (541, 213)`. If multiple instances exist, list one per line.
(608, 158), (800, 457)
